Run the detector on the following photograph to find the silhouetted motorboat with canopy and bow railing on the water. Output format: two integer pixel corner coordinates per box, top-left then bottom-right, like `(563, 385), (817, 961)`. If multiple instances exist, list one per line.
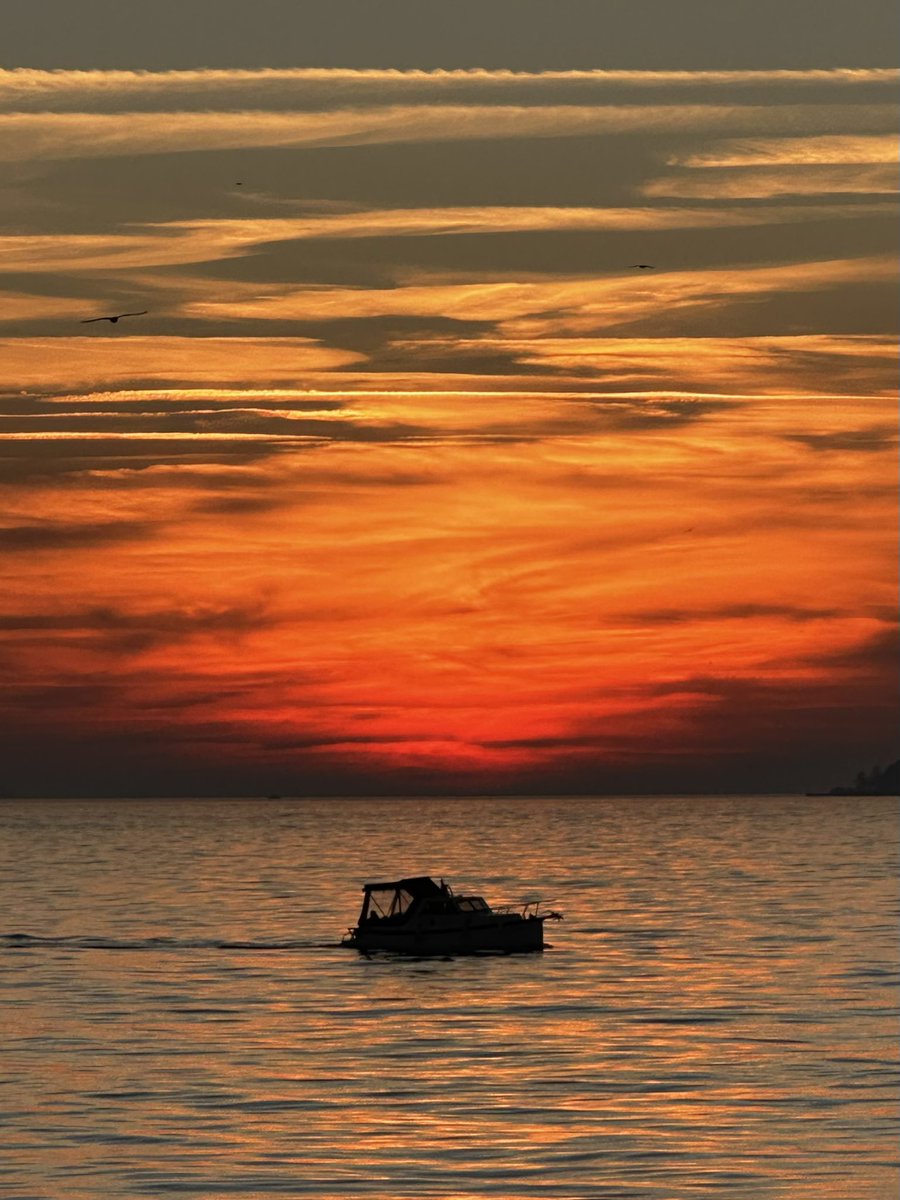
(341, 875), (562, 955)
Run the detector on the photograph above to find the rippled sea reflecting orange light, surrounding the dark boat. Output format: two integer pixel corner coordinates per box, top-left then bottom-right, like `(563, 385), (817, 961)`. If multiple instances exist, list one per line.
(0, 796), (900, 1200)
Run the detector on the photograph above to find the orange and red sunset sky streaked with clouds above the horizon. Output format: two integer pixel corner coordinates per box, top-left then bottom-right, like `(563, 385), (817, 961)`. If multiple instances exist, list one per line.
(0, 9), (900, 796)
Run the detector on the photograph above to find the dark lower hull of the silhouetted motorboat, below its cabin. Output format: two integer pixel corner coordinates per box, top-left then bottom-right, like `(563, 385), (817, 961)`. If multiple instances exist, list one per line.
(343, 917), (544, 955)
